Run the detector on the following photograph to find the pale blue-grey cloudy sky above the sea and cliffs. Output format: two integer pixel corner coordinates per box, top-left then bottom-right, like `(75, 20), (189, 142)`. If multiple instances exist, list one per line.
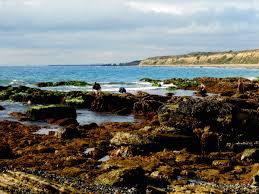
(0, 0), (259, 65)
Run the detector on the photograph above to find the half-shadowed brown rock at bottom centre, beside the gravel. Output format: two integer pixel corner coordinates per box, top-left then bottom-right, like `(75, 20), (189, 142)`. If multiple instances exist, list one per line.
(95, 167), (145, 187)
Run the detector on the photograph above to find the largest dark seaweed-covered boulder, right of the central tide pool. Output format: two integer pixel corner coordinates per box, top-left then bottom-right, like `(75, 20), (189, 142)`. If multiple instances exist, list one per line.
(159, 98), (239, 131)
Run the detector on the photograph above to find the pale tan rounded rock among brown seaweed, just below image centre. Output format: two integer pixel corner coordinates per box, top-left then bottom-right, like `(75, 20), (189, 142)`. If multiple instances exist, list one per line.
(110, 132), (149, 146)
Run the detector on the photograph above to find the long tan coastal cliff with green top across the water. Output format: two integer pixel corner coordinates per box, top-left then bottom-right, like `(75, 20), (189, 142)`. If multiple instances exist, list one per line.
(139, 49), (259, 66)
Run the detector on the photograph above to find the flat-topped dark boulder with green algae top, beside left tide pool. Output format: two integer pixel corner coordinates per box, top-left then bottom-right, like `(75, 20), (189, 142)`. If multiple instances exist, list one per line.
(26, 105), (77, 121)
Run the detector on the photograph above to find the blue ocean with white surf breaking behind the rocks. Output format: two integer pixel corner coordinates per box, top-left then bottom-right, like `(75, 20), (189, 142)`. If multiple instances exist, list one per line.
(0, 65), (259, 93)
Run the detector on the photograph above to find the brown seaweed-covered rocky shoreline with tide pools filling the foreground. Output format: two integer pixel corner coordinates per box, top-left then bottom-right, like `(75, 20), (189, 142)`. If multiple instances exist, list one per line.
(0, 78), (259, 193)
